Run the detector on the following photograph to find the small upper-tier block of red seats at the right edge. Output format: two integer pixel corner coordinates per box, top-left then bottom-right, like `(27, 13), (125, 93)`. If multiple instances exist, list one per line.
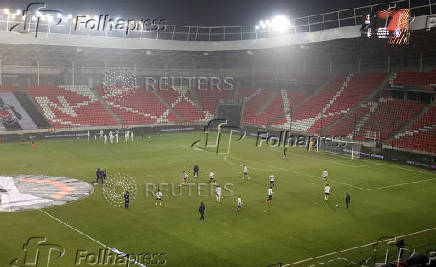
(391, 70), (436, 91)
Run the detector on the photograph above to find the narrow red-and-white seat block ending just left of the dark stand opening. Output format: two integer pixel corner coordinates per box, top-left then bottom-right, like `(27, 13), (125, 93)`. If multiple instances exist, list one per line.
(159, 86), (214, 122)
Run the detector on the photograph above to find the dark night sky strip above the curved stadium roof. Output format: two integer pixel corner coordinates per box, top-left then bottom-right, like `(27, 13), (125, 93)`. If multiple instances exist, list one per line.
(0, 0), (385, 26)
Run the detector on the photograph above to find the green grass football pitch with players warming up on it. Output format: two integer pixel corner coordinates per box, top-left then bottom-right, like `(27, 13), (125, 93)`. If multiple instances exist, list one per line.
(0, 132), (436, 266)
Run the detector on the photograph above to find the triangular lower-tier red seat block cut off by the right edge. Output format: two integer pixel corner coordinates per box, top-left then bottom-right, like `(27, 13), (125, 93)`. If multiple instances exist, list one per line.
(390, 106), (436, 153)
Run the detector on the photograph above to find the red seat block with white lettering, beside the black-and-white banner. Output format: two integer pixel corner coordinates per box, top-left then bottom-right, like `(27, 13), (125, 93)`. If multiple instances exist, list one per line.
(28, 85), (117, 127)
